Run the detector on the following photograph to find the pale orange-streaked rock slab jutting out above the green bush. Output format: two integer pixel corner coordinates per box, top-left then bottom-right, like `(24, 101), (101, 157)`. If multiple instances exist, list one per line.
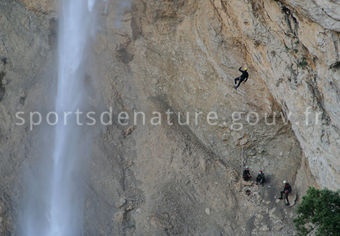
(205, 1), (340, 189)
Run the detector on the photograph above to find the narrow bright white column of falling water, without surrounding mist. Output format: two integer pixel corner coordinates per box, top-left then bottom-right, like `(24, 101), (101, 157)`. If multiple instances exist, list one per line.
(47, 0), (94, 236)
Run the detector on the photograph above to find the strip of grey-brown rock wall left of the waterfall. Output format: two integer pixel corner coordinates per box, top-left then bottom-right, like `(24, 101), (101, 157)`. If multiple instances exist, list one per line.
(0, 0), (56, 235)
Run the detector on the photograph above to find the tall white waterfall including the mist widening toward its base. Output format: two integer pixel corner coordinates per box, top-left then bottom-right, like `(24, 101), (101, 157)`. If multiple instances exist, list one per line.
(20, 0), (95, 236)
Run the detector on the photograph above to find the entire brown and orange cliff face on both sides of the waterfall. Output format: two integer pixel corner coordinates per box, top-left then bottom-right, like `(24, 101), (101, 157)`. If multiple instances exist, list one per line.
(0, 0), (340, 235)
